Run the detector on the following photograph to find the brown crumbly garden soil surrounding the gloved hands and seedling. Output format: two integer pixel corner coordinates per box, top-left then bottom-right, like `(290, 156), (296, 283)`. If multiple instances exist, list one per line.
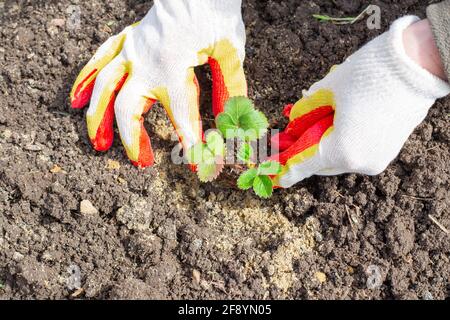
(0, 0), (450, 299)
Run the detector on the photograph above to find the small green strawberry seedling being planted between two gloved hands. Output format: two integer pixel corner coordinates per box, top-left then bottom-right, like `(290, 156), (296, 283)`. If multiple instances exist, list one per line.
(187, 97), (281, 198)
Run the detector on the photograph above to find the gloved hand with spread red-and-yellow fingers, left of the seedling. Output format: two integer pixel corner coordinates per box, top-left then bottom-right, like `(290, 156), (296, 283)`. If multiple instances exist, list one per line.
(71, 0), (247, 167)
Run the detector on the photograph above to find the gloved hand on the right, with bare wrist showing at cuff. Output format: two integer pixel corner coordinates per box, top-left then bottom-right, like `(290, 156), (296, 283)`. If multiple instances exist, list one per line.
(271, 16), (450, 188)
